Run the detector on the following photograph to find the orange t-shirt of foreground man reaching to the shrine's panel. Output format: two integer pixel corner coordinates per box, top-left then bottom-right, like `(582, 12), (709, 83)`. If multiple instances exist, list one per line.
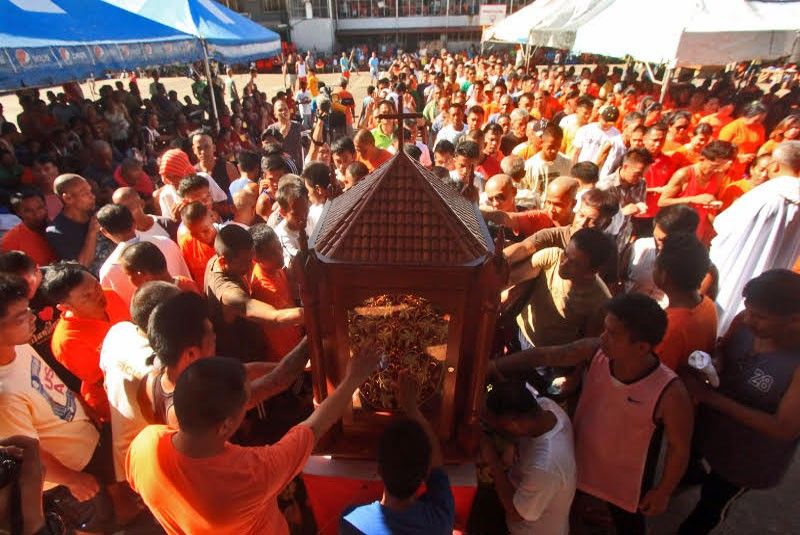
(125, 424), (314, 535)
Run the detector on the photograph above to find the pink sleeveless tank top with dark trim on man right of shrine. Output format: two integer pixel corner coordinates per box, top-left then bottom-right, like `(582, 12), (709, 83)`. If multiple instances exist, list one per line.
(573, 350), (677, 513)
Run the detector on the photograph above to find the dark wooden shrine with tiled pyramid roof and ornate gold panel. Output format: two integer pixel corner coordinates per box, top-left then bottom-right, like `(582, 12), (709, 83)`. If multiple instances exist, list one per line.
(301, 151), (507, 461)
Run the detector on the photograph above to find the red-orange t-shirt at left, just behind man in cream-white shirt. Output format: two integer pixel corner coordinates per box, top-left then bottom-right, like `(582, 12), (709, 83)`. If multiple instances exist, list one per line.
(50, 288), (131, 422)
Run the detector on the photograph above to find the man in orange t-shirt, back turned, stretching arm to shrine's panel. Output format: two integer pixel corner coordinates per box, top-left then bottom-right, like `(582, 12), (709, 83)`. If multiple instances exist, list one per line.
(126, 348), (378, 534)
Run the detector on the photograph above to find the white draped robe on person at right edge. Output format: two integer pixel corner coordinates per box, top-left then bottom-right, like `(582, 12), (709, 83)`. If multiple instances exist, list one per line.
(711, 176), (800, 334)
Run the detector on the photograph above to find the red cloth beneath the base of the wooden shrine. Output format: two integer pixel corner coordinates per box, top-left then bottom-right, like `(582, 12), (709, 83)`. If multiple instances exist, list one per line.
(303, 455), (478, 535)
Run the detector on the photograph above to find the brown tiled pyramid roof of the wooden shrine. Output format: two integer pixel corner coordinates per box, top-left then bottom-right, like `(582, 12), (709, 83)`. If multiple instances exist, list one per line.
(309, 151), (494, 266)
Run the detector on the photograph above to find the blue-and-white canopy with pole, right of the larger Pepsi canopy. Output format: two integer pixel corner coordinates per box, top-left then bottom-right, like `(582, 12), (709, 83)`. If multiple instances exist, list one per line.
(104, 0), (281, 127)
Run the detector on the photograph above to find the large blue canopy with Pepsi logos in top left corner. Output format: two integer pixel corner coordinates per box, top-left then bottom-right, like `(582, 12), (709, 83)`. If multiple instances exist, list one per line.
(0, 0), (203, 91)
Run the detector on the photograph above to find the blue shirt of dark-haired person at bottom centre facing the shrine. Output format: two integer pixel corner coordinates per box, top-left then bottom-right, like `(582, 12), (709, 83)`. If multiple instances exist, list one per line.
(339, 468), (456, 535)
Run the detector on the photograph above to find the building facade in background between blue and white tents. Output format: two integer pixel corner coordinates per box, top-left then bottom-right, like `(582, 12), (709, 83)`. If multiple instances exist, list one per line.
(220, 0), (533, 54)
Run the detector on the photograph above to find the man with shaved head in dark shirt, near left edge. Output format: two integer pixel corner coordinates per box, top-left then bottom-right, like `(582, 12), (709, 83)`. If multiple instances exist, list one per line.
(45, 173), (100, 268)
